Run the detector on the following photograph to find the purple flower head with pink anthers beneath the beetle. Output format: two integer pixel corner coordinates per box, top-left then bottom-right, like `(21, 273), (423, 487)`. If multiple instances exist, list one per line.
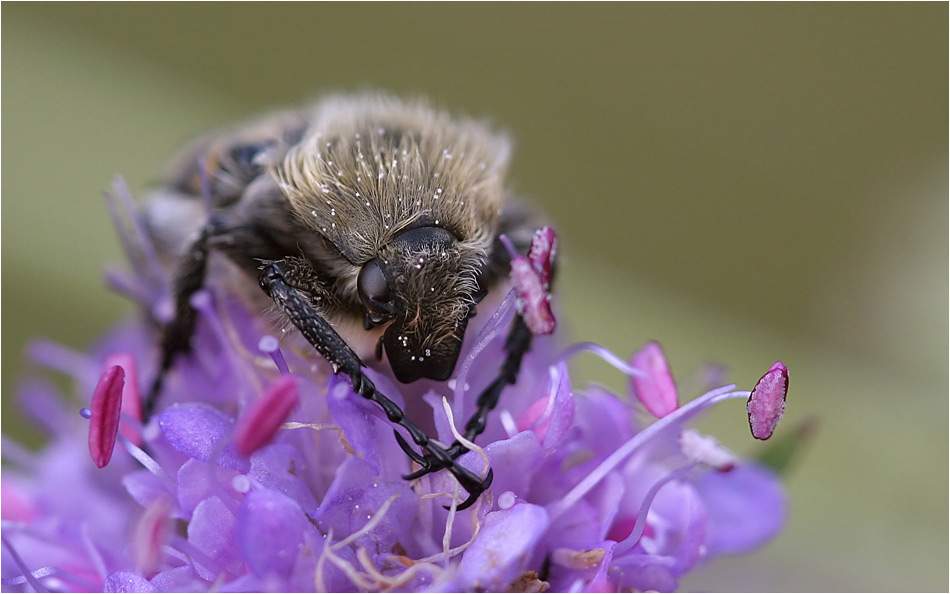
(2, 183), (788, 591)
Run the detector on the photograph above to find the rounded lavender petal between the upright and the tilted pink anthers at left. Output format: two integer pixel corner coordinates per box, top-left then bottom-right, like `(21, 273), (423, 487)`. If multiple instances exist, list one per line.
(158, 402), (249, 472)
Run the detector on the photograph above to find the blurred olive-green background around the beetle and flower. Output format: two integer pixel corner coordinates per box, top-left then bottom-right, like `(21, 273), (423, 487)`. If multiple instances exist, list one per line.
(2, 3), (948, 591)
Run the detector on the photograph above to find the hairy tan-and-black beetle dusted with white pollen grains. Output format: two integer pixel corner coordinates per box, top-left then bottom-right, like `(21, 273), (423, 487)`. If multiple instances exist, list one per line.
(144, 94), (556, 509)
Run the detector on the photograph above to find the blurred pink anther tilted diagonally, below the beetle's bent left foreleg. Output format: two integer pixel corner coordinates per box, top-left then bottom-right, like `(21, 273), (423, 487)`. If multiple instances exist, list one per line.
(234, 375), (300, 456)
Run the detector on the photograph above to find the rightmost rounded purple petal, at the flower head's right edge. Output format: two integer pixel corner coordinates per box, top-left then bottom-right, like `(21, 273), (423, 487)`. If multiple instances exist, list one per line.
(696, 464), (788, 555)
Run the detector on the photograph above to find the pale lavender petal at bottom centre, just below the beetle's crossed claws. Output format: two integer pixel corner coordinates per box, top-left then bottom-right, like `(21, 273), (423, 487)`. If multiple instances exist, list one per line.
(458, 503), (549, 591)
